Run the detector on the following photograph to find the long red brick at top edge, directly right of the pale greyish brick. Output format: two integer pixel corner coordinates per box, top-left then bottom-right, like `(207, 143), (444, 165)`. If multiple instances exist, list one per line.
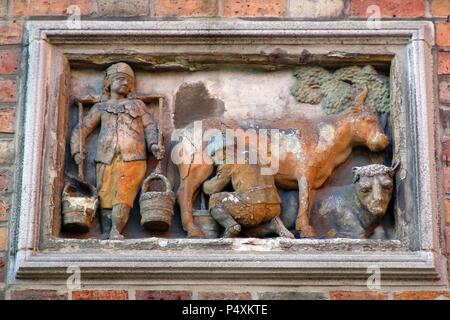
(350, 0), (425, 18)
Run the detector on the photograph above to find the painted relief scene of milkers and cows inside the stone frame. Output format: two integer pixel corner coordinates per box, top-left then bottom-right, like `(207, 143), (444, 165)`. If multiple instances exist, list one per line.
(60, 62), (398, 240)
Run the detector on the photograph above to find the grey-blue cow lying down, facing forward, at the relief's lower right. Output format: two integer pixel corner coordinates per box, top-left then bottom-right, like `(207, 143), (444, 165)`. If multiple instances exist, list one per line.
(311, 164), (396, 239)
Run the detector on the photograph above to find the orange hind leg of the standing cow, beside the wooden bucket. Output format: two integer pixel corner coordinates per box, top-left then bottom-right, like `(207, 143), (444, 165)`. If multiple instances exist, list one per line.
(177, 163), (214, 238)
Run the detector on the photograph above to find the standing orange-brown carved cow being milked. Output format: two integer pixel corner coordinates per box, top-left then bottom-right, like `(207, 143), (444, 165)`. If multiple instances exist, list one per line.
(176, 89), (389, 238)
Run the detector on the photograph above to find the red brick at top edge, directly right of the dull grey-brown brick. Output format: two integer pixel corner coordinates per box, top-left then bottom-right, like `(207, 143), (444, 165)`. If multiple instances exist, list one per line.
(155, 0), (218, 17)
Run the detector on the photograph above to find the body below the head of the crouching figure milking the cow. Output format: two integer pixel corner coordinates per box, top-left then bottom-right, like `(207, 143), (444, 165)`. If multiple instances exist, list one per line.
(203, 164), (294, 238)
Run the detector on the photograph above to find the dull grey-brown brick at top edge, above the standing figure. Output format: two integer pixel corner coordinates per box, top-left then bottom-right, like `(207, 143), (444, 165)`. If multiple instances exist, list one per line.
(97, 0), (149, 17)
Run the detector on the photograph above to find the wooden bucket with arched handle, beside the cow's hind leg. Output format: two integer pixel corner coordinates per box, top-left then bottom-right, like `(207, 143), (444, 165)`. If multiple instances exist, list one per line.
(139, 173), (175, 231)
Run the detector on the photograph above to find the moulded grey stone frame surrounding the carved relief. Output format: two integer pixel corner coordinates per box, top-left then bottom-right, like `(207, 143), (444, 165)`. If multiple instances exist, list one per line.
(8, 19), (446, 287)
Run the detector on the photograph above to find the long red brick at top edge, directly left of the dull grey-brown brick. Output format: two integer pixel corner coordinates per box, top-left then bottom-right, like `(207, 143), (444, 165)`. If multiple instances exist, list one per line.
(12, 0), (95, 17)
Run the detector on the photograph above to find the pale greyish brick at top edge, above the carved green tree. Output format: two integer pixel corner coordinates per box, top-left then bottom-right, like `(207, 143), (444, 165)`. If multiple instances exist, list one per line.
(288, 0), (345, 18)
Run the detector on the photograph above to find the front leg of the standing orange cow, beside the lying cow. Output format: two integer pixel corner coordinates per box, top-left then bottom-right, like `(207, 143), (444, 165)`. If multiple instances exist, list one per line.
(295, 175), (317, 238)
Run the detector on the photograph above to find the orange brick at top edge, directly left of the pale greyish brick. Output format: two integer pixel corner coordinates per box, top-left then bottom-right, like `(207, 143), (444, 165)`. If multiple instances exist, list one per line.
(222, 0), (286, 17)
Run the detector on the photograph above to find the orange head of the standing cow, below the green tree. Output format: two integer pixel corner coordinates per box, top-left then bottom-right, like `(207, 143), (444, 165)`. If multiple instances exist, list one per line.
(345, 105), (389, 152)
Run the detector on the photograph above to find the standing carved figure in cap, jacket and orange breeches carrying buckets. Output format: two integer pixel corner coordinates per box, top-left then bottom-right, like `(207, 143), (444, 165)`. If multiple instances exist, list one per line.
(70, 63), (163, 240)
